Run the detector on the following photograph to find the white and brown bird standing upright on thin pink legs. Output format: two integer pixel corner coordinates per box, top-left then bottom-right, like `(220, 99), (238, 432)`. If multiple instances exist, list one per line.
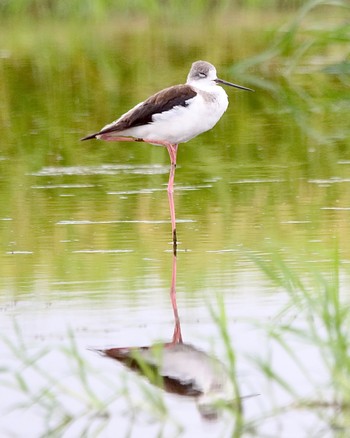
(82, 61), (252, 246)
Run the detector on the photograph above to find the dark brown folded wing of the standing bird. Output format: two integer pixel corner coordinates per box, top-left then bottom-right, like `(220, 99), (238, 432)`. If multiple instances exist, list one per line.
(82, 84), (197, 140)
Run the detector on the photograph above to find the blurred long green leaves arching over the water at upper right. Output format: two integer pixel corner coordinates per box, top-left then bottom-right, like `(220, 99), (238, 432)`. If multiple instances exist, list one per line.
(231, 0), (350, 144)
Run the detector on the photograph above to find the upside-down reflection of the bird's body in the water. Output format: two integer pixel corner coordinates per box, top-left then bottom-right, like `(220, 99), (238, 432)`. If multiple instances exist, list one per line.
(99, 342), (233, 418)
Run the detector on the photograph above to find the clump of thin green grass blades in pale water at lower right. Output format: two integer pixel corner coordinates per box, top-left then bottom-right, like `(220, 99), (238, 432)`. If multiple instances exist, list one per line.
(252, 251), (350, 431)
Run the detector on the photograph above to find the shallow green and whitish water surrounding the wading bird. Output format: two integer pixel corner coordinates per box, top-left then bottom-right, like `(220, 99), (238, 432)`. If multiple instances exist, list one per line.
(0, 12), (350, 437)
